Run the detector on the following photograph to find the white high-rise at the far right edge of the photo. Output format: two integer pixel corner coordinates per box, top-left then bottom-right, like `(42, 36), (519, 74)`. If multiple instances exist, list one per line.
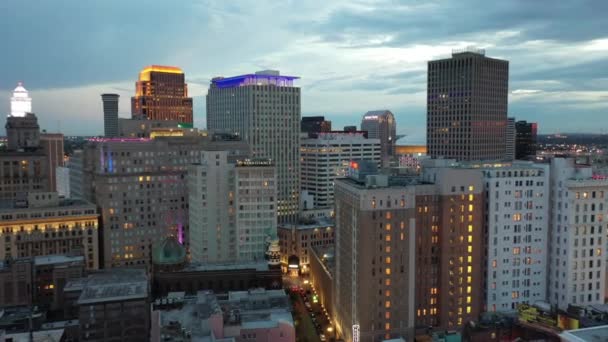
(548, 158), (608, 310)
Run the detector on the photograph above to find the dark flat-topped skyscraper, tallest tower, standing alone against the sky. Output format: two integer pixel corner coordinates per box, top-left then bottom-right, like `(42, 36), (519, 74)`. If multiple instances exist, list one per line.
(427, 50), (509, 161)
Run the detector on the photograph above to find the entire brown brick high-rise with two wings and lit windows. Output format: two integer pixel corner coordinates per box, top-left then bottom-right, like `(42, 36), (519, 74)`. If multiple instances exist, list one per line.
(334, 161), (484, 341)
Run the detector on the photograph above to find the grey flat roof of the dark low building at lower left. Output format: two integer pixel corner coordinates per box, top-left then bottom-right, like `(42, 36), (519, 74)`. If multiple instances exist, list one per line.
(78, 269), (148, 305)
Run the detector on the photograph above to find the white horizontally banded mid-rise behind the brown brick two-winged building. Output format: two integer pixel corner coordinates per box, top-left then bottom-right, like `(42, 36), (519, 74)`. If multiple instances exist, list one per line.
(300, 132), (381, 208)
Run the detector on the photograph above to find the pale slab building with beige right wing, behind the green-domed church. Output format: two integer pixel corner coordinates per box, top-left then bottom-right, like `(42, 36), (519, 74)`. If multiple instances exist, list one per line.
(188, 151), (277, 264)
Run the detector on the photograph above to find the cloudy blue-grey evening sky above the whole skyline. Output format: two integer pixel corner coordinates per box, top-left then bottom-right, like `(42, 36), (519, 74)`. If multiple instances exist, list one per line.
(0, 0), (608, 143)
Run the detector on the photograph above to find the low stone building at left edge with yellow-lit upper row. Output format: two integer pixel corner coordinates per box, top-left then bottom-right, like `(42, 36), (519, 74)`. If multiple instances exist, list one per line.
(0, 192), (99, 270)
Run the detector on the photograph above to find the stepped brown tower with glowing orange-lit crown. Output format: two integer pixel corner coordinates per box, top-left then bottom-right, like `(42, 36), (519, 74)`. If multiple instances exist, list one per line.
(131, 65), (193, 127)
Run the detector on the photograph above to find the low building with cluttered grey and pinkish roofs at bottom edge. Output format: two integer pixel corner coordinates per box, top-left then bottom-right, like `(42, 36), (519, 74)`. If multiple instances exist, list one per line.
(152, 289), (296, 342)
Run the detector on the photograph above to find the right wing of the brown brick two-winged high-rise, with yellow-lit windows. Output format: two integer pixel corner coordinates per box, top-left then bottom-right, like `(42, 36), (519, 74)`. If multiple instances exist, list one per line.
(415, 164), (485, 330)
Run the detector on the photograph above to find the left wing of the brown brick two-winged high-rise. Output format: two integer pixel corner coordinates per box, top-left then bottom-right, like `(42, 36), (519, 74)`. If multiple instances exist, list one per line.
(333, 168), (416, 341)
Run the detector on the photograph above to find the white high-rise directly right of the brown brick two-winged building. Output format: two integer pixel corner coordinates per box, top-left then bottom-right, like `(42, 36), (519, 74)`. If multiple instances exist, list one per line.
(483, 162), (549, 312)
